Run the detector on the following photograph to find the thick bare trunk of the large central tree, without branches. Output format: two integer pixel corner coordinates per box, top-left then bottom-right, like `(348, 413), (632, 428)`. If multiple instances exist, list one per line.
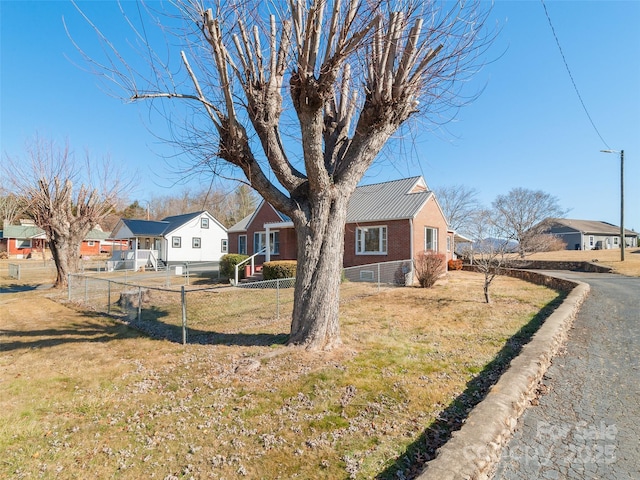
(289, 195), (348, 350)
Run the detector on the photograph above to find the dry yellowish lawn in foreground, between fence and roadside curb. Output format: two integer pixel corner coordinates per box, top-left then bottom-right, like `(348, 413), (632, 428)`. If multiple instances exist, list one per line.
(0, 272), (558, 479)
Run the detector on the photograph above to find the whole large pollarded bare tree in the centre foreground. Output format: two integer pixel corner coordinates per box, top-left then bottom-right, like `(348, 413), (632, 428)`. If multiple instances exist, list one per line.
(76, 0), (490, 349)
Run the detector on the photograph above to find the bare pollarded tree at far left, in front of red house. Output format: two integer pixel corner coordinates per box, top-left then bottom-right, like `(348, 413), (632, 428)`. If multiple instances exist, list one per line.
(3, 138), (125, 287)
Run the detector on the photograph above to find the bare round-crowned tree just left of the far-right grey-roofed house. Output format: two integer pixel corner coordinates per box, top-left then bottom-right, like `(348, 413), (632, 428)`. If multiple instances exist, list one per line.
(492, 188), (566, 258)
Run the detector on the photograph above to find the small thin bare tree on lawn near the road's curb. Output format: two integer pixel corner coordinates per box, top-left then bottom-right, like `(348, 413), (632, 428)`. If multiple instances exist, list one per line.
(458, 209), (512, 303)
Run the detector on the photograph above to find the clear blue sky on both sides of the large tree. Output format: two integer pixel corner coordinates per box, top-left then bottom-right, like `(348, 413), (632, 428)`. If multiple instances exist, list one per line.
(0, 0), (640, 230)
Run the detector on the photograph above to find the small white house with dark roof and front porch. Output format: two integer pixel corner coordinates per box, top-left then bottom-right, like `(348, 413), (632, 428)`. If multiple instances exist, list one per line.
(107, 211), (228, 270)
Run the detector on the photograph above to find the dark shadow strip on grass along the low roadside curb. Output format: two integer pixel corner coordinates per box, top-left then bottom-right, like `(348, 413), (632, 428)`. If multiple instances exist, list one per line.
(375, 292), (567, 480)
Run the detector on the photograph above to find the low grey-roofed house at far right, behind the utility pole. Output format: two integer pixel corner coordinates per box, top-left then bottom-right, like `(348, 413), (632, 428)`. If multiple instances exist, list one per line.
(545, 218), (638, 250)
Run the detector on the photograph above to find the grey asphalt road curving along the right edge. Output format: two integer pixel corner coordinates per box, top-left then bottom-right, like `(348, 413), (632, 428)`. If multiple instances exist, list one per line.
(494, 272), (640, 480)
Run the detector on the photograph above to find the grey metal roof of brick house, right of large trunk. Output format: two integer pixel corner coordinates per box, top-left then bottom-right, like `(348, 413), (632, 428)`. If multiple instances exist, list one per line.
(347, 177), (433, 223)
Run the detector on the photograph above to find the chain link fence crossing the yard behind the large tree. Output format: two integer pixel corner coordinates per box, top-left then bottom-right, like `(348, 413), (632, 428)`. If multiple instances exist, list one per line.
(67, 261), (413, 345)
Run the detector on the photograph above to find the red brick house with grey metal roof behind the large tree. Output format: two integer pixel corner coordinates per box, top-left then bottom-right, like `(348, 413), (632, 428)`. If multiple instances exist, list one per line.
(229, 177), (453, 267)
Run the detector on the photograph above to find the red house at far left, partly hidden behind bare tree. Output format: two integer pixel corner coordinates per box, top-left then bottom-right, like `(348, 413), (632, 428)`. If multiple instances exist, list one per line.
(0, 221), (109, 258)
